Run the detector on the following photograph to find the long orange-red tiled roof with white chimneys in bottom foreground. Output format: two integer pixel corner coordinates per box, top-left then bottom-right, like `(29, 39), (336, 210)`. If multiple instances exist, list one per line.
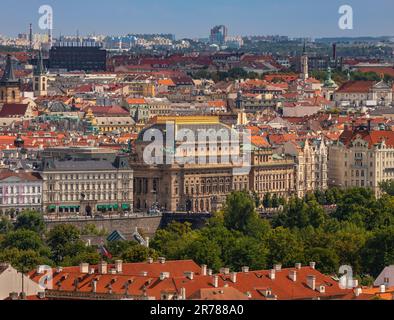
(29, 261), (352, 300)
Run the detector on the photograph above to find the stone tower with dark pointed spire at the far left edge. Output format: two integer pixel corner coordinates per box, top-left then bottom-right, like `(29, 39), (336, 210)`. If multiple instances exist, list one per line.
(0, 54), (21, 104)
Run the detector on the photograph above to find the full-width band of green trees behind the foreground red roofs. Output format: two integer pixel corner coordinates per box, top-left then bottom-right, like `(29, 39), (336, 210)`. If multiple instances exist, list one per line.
(0, 184), (394, 284)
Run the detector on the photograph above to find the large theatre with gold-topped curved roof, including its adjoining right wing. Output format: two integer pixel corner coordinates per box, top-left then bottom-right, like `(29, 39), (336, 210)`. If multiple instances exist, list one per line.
(132, 116), (295, 212)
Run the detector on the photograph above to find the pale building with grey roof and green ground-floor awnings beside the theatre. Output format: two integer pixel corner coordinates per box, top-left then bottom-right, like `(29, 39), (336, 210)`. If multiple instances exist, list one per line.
(40, 148), (133, 215)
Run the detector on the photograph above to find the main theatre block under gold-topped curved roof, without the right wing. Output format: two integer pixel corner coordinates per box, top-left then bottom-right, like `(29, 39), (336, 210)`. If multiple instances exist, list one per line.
(132, 116), (249, 212)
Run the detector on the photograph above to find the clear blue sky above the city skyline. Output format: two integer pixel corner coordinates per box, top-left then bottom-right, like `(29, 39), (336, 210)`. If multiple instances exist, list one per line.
(0, 0), (394, 38)
